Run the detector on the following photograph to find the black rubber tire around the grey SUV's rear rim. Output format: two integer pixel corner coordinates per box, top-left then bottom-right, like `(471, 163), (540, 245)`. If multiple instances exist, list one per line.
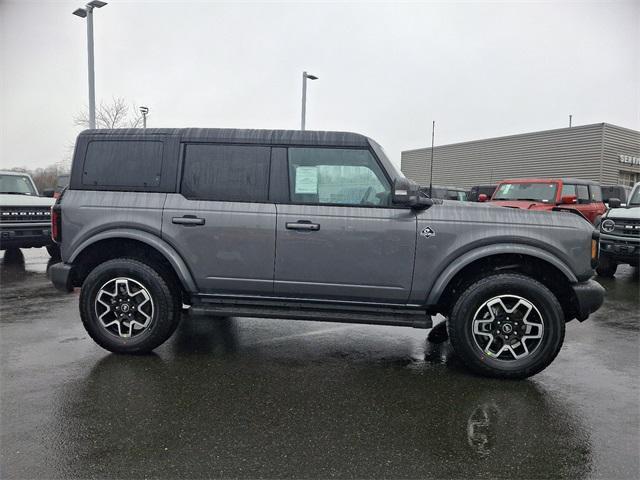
(80, 258), (182, 354)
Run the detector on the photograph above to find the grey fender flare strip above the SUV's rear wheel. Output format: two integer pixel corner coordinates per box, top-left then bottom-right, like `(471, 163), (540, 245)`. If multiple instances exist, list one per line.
(67, 228), (197, 293)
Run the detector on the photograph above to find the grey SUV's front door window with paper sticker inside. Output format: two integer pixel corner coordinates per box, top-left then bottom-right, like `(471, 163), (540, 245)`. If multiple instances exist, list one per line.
(289, 148), (391, 206)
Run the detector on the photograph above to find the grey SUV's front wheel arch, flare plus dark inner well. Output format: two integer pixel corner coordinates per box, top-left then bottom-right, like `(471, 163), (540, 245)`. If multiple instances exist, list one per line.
(426, 244), (578, 320)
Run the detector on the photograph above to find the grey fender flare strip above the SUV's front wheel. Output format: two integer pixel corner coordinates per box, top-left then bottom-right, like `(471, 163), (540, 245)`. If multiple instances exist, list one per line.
(426, 243), (578, 305)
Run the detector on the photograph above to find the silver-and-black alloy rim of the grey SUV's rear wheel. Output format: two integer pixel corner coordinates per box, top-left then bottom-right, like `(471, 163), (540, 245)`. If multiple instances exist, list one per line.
(95, 277), (154, 338)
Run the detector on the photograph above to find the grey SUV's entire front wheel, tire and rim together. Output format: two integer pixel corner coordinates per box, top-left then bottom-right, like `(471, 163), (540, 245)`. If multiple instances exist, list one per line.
(449, 273), (565, 378)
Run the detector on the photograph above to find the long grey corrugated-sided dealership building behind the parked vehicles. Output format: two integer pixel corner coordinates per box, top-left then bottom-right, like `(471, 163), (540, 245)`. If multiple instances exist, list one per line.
(401, 123), (640, 188)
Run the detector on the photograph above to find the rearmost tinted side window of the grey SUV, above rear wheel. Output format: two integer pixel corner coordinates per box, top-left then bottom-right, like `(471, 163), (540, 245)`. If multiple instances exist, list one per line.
(82, 141), (162, 187)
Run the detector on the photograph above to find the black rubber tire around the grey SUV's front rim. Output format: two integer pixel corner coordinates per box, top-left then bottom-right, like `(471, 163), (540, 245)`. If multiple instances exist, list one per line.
(448, 273), (565, 379)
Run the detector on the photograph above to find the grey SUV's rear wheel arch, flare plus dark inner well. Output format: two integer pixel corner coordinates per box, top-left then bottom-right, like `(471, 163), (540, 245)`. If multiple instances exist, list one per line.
(67, 229), (197, 292)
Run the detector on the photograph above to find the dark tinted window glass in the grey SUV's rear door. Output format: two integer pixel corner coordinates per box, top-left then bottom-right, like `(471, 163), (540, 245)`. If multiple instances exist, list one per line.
(181, 145), (271, 202)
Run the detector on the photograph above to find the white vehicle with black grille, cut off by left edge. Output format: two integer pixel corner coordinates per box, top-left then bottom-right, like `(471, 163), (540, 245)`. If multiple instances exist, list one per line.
(0, 171), (60, 257)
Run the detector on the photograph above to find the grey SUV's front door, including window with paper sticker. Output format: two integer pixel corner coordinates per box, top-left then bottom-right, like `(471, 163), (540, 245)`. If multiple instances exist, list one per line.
(275, 147), (416, 303)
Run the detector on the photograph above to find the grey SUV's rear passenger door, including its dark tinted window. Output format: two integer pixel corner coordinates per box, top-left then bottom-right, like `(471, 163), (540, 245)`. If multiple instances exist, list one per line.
(162, 143), (276, 295)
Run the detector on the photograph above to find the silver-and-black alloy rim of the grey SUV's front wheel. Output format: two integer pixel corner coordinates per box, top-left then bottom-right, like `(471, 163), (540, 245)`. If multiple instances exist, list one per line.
(471, 295), (544, 362)
